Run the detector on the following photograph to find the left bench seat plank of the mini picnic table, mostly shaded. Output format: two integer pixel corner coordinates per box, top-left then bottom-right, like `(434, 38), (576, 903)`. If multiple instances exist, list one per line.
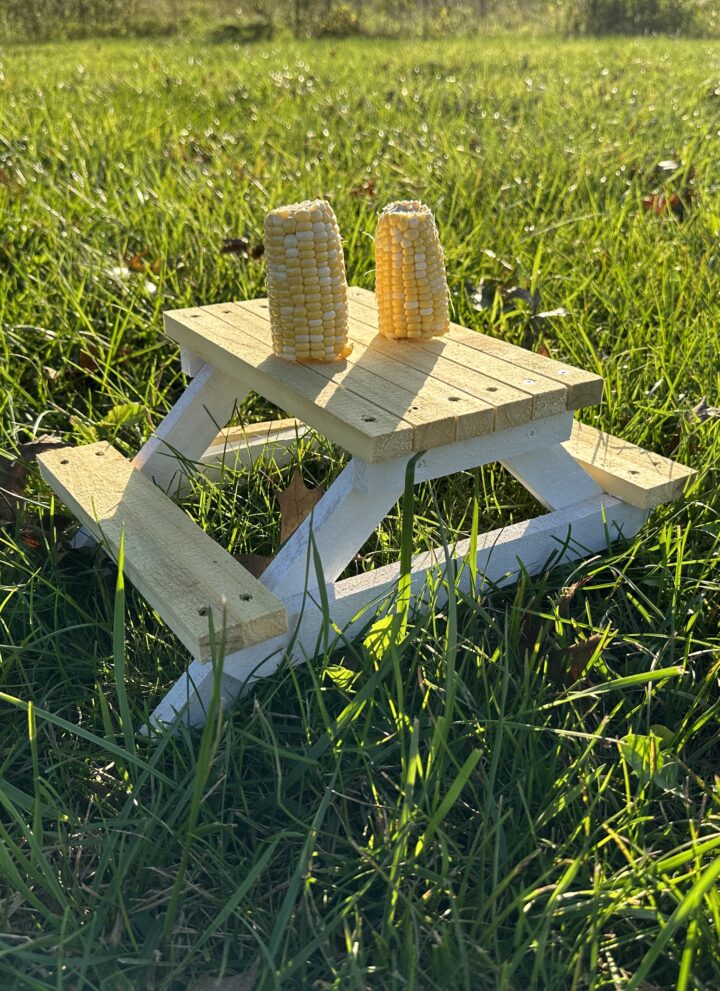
(38, 442), (287, 659)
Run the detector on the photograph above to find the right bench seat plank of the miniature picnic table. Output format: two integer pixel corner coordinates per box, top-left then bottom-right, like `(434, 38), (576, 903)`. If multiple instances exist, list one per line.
(563, 422), (697, 509)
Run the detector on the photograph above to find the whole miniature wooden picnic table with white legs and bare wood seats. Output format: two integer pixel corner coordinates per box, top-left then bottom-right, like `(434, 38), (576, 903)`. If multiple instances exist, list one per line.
(39, 288), (694, 725)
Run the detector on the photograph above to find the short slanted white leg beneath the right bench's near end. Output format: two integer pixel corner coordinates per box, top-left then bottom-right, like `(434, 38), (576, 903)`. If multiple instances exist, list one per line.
(500, 444), (603, 509)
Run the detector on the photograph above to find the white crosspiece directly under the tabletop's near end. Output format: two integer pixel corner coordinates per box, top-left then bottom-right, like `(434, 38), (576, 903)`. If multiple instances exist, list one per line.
(351, 413), (572, 502)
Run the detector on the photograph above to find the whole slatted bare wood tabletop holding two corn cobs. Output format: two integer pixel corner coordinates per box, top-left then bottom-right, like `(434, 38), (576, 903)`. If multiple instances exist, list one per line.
(165, 287), (603, 462)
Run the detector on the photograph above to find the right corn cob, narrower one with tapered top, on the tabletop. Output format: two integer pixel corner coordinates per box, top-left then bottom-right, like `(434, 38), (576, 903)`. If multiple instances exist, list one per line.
(375, 200), (449, 338)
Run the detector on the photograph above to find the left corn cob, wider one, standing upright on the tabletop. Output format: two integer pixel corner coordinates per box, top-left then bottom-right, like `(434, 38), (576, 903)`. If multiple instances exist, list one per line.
(265, 200), (348, 361)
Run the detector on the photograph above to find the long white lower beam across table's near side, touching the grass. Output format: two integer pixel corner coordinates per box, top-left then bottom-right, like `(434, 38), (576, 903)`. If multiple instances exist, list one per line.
(150, 495), (647, 727)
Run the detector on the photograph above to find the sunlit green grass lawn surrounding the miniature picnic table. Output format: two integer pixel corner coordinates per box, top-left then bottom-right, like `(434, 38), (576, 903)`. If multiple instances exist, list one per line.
(0, 31), (720, 991)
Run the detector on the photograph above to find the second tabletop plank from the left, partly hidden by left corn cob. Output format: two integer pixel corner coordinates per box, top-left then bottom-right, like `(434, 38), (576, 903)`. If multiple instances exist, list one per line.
(203, 300), (455, 451)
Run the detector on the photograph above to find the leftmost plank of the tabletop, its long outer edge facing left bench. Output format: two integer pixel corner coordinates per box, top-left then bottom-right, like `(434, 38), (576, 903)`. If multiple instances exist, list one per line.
(164, 308), (413, 462)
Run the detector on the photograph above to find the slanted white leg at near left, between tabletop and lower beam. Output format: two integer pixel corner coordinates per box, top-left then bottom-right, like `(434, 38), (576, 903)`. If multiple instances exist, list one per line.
(262, 462), (402, 599)
